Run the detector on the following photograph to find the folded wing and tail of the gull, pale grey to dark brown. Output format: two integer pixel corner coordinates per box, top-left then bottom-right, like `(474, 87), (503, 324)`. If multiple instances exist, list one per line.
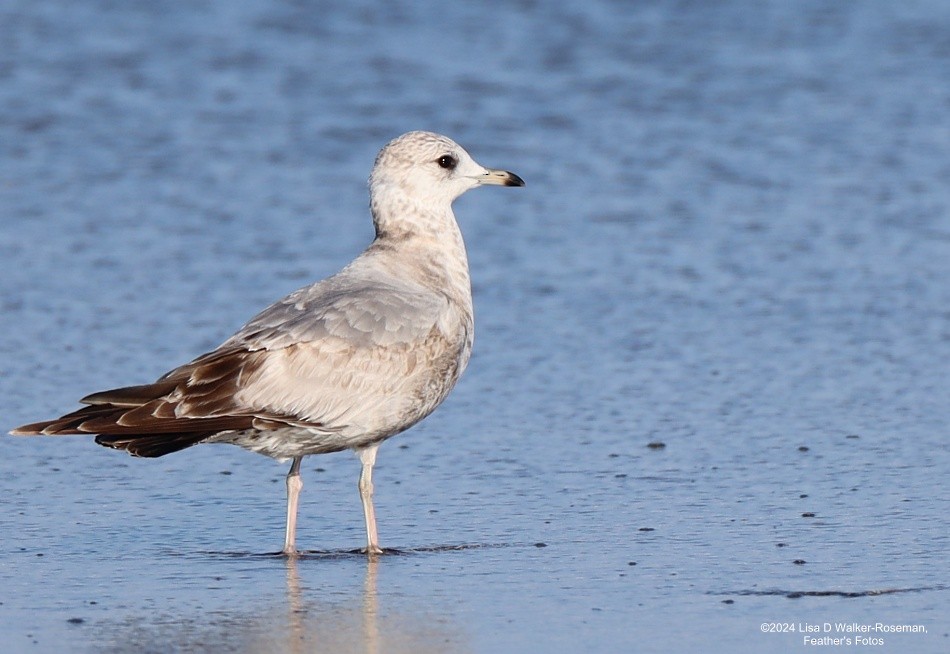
(11, 268), (471, 456)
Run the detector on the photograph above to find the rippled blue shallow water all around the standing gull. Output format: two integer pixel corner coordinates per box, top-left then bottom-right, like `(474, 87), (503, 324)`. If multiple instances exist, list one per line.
(0, 0), (950, 653)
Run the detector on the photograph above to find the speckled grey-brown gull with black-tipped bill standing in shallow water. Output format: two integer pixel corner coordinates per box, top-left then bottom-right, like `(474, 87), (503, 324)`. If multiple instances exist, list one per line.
(11, 132), (524, 557)
